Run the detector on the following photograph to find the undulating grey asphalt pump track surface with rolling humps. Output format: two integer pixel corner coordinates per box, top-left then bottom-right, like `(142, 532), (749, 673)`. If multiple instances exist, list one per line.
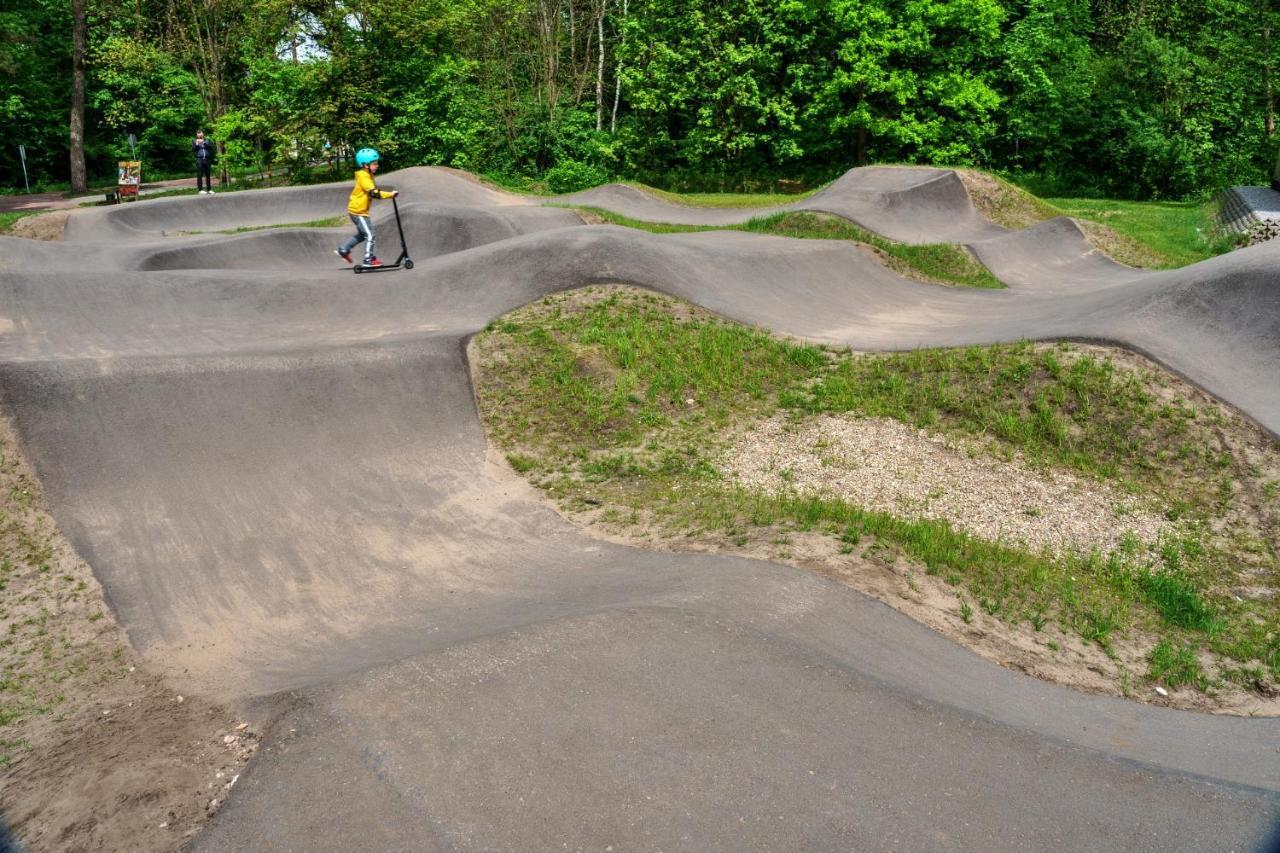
(0, 169), (1280, 850)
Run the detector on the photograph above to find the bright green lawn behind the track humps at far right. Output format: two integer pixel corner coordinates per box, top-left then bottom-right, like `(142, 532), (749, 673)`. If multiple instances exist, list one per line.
(1044, 199), (1230, 268)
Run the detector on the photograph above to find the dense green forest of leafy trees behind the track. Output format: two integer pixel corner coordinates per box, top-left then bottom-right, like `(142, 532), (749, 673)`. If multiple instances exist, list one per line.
(0, 0), (1280, 199)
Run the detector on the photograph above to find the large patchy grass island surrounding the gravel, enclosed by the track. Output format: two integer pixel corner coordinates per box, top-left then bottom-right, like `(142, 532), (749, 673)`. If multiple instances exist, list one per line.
(476, 288), (1280, 690)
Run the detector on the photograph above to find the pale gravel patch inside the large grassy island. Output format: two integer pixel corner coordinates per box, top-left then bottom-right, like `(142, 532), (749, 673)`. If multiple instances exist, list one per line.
(721, 415), (1170, 552)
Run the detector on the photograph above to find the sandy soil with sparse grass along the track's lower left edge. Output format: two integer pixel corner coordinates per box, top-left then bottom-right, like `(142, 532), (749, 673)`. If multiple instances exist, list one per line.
(0, 419), (257, 852)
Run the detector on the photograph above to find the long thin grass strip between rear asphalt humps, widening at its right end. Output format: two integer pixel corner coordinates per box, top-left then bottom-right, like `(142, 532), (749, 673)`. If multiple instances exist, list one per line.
(573, 207), (1004, 288)
